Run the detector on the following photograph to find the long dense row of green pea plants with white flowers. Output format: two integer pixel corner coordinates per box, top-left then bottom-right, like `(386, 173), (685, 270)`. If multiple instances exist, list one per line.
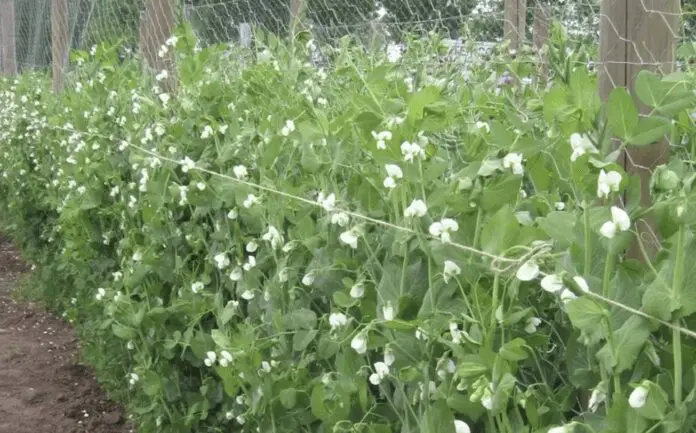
(0, 22), (696, 433)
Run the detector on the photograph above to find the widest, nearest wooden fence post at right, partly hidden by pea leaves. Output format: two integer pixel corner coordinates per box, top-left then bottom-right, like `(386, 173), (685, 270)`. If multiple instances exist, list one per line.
(599, 0), (680, 260)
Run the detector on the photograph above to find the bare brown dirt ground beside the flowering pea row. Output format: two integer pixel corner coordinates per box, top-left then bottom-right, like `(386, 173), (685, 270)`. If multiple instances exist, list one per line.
(0, 236), (132, 433)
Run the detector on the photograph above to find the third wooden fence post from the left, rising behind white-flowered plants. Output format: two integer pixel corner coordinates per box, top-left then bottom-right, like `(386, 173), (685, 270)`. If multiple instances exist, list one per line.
(140, 0), (176, 91)
